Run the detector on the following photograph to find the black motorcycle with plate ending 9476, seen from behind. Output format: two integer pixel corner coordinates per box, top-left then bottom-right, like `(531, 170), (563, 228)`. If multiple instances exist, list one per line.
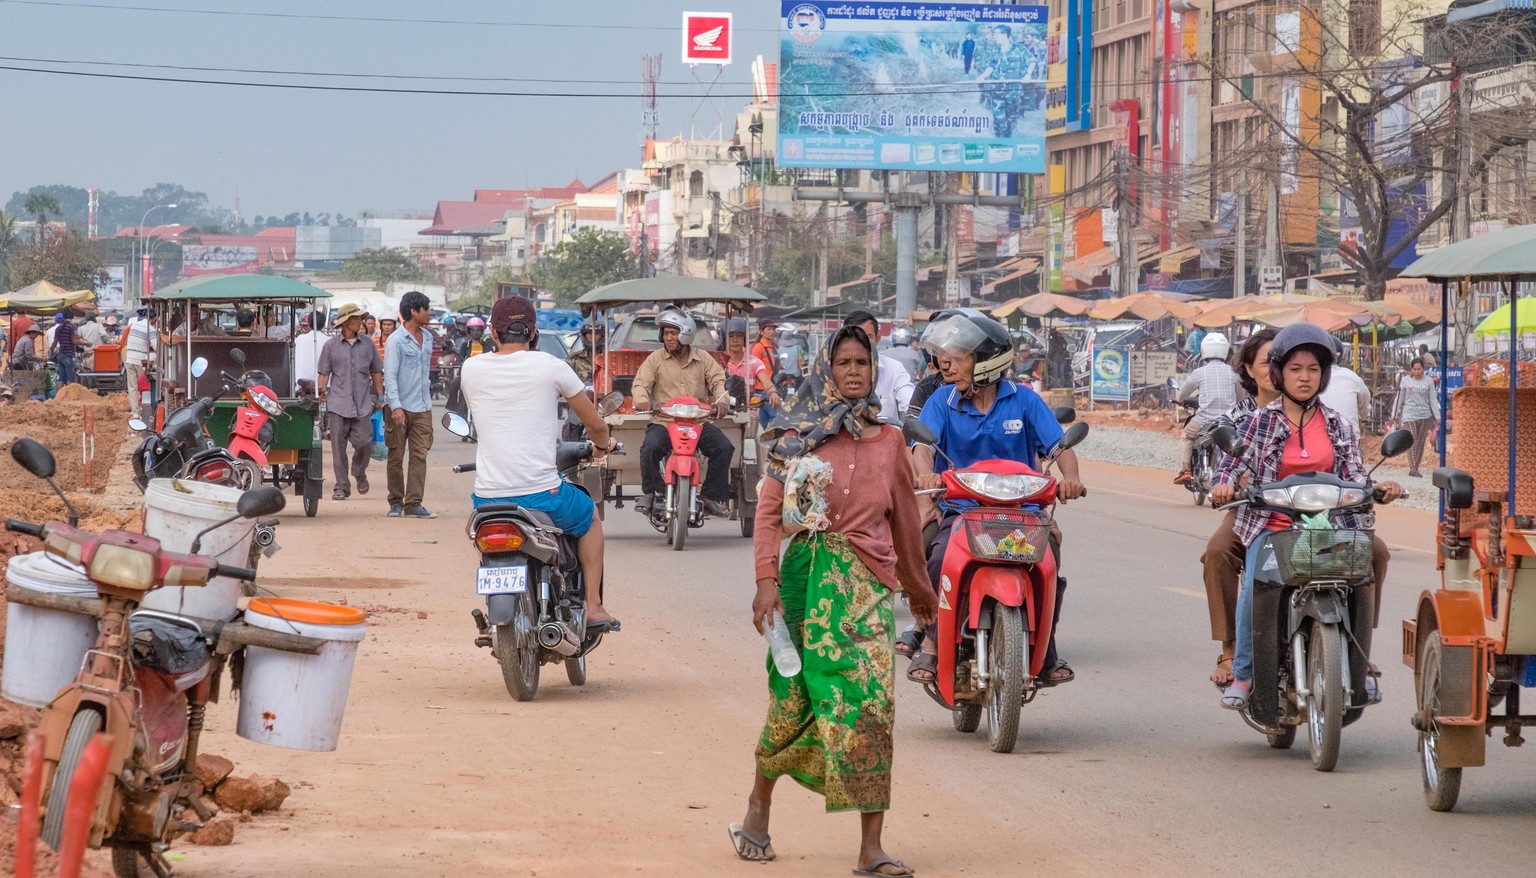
(442, 408), (624, 701)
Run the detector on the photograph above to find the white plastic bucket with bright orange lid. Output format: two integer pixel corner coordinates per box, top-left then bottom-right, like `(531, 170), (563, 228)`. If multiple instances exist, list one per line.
(235, 597), (367, 751)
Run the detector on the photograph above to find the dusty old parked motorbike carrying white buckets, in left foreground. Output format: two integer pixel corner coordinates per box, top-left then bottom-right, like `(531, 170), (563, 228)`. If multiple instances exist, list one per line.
(5, 439), (293, 878)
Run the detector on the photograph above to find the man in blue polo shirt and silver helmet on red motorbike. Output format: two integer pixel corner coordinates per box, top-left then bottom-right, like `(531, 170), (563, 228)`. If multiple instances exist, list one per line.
(906, 309), (1083, 686)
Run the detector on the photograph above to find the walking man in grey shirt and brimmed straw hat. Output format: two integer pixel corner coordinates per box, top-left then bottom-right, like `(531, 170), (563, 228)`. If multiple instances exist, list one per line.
(316, 305), (384, 500)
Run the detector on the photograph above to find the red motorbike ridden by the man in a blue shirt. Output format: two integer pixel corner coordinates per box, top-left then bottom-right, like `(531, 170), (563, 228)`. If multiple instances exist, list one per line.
(902, 418), (1087, 754)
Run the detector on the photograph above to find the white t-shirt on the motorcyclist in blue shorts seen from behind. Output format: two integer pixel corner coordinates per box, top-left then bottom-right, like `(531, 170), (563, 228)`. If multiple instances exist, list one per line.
(459, 350), (584, 497)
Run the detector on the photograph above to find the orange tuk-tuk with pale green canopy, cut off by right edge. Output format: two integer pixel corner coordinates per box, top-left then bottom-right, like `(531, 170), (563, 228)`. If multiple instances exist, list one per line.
(1402, 226), (1536, 810)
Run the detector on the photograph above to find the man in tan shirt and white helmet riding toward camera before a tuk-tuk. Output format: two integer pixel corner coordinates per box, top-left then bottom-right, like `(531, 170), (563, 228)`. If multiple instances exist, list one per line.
(630, 309), (736, 516)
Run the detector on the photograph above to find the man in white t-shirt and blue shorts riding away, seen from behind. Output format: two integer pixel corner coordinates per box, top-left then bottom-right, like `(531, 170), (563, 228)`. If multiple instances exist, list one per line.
(459, 296), (617, 629)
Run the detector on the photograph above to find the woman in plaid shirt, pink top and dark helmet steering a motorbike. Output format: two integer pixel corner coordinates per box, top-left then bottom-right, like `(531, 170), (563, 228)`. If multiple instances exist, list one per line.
(1210, 324), (1402, 711)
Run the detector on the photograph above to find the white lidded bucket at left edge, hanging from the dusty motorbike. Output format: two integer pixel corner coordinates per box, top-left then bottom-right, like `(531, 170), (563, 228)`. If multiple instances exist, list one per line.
(0, 551), (97, 708)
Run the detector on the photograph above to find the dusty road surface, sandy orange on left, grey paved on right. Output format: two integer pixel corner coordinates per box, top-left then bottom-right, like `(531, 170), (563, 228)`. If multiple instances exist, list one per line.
(177, 434), (1536, 878)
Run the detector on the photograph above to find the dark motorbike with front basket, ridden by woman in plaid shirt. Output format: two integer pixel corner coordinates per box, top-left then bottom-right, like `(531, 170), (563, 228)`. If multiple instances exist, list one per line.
(1213, 425), (1413, 771)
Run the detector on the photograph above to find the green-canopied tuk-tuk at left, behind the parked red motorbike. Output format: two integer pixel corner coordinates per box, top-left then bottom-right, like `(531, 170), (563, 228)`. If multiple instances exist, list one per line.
(144, 275), (330, 517)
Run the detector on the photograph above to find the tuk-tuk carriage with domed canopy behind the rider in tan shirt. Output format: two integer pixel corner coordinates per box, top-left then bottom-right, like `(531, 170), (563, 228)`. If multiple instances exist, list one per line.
(576, 276), (766, 550)
